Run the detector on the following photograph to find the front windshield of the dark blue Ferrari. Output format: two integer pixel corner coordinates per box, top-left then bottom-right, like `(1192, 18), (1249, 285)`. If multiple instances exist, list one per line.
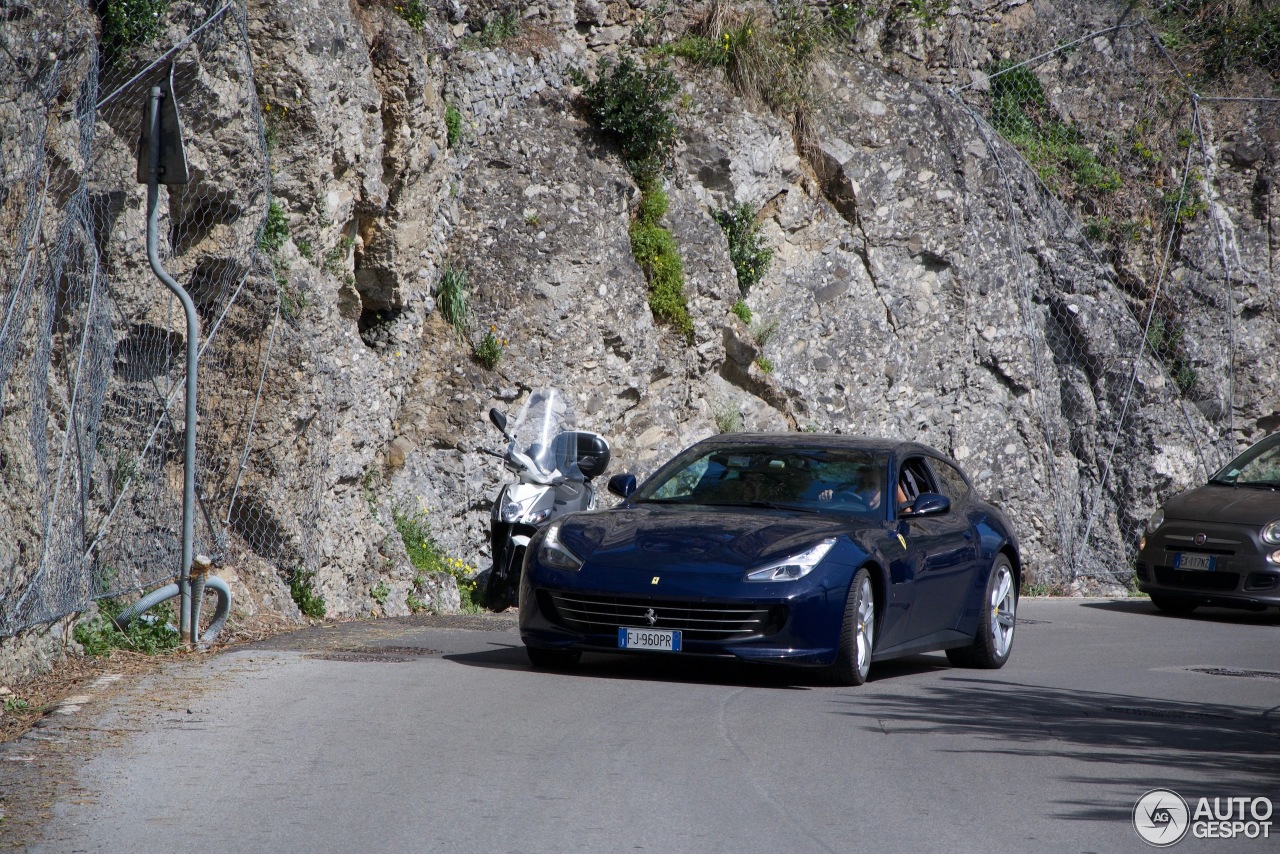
(634, 446), (887, 519)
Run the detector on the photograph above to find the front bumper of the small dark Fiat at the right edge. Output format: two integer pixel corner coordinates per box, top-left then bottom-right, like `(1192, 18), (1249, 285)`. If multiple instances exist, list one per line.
(1134, 520), (1280, 611)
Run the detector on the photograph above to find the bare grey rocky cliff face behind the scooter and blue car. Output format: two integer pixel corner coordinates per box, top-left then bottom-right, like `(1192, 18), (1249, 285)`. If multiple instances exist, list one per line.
(0, 0), (1280, 665)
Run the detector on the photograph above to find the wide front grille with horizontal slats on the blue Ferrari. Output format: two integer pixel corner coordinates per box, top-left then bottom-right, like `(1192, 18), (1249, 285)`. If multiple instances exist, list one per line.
(540, 592), (787, 640)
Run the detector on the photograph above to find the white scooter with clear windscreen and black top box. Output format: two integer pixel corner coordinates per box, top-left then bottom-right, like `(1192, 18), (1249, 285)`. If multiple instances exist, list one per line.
(484, 388), (609, 611)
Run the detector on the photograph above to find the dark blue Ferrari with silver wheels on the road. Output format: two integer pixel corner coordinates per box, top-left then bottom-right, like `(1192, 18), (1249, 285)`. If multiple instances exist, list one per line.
(520, 433), (1021, 685)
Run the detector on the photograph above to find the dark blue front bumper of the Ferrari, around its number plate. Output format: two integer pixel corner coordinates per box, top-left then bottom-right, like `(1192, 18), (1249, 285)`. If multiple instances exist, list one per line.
(520, 565), (852, 667)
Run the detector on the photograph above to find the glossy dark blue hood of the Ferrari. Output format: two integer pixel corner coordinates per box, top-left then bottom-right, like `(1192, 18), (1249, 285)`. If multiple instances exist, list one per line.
(559, 506), (850, 572)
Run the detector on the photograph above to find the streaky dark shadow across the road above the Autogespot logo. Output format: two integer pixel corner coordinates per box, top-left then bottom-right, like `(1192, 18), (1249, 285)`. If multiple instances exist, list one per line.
(835, 675), (1280, 821)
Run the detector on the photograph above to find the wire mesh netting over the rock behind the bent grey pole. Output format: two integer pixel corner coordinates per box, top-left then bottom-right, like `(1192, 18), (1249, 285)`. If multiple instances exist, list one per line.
(0, 0), (317, 635)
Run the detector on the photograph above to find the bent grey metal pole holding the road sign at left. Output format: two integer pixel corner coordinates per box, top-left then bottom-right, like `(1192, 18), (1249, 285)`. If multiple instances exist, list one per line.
(147, 86), (200, 644)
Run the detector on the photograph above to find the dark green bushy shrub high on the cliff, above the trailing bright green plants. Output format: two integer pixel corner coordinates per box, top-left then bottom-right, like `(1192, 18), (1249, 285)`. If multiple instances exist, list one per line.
(582, 55), (680, 182)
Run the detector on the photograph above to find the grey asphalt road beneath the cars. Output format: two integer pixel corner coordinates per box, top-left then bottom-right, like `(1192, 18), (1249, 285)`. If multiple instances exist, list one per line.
(12, 599), (1280, 854)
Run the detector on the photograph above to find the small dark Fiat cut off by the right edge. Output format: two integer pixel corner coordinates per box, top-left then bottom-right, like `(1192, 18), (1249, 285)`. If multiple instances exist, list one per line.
(1135, 433), (1280, 613)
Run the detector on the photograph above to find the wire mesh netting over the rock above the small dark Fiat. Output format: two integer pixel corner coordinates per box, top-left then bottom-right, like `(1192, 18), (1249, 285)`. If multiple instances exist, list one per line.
(955, 6), (1280, 583)
